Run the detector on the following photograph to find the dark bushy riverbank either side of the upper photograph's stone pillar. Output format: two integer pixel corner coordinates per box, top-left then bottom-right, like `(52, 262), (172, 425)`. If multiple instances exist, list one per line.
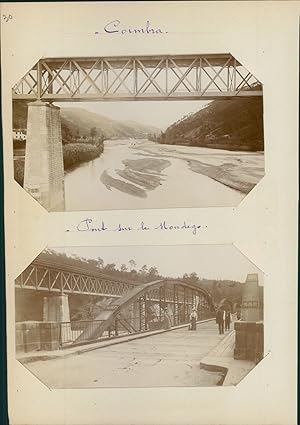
(14, 141), (104, 187)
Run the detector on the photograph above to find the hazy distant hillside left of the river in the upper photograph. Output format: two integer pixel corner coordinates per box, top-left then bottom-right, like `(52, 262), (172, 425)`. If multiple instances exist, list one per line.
(13, 102), (160, 141)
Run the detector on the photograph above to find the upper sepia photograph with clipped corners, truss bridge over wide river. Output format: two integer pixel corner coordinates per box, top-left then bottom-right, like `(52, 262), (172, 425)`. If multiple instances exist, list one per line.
(12, 53), (264, 212)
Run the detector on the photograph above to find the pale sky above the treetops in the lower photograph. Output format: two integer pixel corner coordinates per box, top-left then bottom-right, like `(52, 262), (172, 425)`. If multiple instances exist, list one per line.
(47, 245), (263, 284)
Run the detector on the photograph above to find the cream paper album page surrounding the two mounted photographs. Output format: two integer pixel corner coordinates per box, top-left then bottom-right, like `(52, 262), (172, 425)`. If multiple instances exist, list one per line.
(1, 2), (299, 425)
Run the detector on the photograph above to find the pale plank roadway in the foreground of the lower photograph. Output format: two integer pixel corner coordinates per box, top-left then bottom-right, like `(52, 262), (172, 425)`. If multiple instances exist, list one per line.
(26, 320), (224, 388)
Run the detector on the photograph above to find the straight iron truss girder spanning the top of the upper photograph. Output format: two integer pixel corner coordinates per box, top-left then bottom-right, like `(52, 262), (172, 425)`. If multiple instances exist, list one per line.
(12, 54), (262, 102)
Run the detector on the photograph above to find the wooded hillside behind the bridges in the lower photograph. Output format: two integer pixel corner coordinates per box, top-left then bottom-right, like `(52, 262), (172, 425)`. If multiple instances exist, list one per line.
(16, 249), (243, 321)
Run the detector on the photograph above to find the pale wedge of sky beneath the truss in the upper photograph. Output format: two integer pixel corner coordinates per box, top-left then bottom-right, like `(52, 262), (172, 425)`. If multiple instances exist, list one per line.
(56, 100), (210, 131)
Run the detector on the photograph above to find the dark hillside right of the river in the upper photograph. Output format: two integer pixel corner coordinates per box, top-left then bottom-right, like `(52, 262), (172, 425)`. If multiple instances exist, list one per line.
(158, 98), (264, 151)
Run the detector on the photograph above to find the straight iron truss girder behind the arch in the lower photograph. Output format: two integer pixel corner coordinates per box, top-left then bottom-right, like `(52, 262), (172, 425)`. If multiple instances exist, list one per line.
(15, 260), (135, 298)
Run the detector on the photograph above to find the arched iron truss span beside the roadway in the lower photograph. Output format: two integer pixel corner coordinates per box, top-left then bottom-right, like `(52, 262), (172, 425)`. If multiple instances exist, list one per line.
(74, 279), (215, 344)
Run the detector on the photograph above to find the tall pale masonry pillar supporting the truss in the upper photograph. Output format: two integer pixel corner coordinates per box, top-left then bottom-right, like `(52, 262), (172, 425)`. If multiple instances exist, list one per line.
(24, 101), (65, 212)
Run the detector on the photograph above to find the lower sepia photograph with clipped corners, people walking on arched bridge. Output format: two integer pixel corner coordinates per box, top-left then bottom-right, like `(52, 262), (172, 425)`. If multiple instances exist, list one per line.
(15, 245), (264, 389)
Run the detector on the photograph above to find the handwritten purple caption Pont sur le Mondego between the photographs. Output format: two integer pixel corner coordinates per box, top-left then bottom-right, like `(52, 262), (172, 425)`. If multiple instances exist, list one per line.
(66, 217), (207, 236)
